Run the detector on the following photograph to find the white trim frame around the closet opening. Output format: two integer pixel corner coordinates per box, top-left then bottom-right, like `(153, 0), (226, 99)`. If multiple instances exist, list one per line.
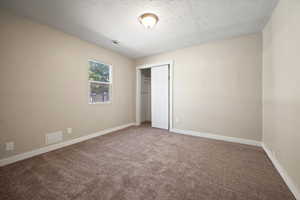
(135, 60), (174, 131)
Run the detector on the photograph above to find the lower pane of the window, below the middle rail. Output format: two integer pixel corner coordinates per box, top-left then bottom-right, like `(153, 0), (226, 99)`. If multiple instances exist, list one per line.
(90, 83), (110, 103)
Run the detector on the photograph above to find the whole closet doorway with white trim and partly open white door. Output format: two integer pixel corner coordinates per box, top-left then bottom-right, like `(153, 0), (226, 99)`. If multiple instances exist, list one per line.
(136, 62), (173, 130)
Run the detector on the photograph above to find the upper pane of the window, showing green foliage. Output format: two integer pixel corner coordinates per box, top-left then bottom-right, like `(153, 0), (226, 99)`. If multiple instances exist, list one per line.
(89, 61), (110, 82)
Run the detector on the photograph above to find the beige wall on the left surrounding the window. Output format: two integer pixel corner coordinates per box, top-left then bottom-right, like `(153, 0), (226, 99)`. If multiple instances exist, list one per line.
(0, 10), (135, 158)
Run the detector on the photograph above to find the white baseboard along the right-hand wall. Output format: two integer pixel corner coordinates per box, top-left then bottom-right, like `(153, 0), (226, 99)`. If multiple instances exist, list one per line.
(262, 143), (300, 200)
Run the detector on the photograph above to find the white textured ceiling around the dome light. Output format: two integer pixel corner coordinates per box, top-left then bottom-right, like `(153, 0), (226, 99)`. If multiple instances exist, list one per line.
(0, 0), (278, 58)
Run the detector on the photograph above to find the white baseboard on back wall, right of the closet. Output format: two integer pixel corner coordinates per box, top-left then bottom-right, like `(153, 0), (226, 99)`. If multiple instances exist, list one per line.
(170, 128), (261, 147)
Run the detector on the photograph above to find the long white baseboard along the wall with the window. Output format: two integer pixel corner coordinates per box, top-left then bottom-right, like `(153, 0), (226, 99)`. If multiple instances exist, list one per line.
(0, 123), (135, 167)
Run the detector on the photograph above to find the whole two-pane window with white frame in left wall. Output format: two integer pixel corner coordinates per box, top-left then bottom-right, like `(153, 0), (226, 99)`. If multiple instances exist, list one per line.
(89, 60), (112, 104)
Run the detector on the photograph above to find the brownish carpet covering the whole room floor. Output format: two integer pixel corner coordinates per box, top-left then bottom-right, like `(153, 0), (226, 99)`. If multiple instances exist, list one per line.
(0, 125), (295, 200)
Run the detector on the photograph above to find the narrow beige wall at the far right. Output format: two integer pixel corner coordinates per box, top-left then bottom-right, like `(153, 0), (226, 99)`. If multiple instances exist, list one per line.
(263, 0), (300, 192)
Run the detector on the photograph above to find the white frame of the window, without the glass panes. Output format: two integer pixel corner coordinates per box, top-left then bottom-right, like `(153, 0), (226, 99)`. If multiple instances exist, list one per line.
(87, 59), (113, 105)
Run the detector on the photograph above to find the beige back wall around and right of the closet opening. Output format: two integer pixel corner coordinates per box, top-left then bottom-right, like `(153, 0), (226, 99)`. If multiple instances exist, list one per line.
(136, 34), (262, 141)
